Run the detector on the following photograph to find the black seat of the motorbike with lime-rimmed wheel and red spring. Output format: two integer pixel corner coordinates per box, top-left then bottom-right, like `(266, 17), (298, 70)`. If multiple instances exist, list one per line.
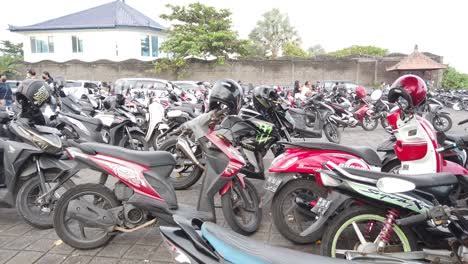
(344, 168), (458, 188)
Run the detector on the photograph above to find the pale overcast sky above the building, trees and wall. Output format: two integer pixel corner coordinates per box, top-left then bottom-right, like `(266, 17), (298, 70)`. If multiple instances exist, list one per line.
(0, 0), (468, 73)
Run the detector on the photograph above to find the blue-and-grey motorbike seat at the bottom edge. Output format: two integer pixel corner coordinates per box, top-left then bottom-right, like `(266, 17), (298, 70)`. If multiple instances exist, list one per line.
(201, 222), (345, 264)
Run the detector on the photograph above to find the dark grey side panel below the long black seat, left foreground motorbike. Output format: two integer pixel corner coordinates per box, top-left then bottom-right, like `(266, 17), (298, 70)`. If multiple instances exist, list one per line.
(143, 166), (177, 210)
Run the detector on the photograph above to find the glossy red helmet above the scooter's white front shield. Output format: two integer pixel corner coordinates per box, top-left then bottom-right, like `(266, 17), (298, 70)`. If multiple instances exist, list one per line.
(388, 74), (427, 108)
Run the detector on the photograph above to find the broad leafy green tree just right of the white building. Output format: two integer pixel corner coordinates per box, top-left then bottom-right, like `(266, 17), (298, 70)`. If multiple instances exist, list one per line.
(155, 3), (246, 75)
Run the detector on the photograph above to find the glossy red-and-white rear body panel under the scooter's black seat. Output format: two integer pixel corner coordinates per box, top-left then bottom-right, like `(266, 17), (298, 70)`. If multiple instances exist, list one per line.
(269, 148), (371, 175)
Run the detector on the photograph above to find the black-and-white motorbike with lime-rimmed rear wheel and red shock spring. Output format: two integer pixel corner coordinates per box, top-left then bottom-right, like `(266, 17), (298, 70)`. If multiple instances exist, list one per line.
(313, 160), (468, 263)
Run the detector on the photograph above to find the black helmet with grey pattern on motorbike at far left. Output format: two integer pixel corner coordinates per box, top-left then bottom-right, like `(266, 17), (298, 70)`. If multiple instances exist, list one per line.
(15, 79), (50, 107)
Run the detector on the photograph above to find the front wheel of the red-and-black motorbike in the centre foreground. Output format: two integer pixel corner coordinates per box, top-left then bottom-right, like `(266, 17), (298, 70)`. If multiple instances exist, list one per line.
(221, 178), (262, 236)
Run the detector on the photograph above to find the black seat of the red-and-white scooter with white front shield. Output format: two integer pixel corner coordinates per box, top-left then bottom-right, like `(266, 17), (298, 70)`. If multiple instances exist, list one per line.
(280, 142), (382, 167)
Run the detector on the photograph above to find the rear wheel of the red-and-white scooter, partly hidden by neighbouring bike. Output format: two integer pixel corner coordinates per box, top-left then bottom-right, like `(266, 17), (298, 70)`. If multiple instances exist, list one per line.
(271, 179), (326, 244)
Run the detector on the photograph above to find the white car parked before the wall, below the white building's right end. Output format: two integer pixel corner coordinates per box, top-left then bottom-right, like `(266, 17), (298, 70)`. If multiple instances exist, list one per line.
(114, 78), (172, 97)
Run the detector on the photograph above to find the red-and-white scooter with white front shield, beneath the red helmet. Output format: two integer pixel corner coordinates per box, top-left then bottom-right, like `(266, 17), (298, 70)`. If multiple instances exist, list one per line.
(262, 105), (468, 243)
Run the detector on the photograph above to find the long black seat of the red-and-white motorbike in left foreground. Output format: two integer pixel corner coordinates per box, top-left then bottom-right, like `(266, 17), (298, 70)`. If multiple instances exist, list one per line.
(80, 142), (176, 167)
